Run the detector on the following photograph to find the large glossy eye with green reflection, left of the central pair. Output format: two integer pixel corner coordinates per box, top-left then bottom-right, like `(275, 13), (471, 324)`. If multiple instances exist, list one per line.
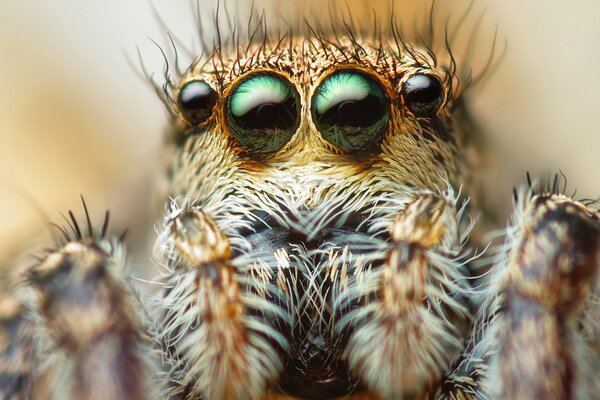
(227, 74), (300, 153)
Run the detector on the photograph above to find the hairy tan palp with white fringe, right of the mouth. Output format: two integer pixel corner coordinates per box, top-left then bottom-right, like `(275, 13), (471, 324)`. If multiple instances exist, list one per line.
(337, 192), (471, 399)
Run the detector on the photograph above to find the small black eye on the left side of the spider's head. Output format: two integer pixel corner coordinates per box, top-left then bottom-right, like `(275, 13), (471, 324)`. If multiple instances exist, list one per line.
(177, 81), (218, 124)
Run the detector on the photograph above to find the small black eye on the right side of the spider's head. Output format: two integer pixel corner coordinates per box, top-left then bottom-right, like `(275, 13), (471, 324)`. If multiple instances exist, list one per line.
(402, 74), (444, 117)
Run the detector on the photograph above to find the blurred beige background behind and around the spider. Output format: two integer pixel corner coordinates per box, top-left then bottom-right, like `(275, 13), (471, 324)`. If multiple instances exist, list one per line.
(0, 0), (600, 260)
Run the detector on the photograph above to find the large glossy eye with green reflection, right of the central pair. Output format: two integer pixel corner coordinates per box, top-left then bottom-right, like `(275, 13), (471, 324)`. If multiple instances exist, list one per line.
(312, 70), (390, 151)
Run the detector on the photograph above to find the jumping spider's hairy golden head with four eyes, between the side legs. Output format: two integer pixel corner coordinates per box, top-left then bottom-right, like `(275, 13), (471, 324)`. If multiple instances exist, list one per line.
(159, 37), (470, 398)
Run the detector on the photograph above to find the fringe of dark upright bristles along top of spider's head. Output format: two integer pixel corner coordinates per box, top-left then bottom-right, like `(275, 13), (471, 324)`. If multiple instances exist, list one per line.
(139, 1), (506, 117)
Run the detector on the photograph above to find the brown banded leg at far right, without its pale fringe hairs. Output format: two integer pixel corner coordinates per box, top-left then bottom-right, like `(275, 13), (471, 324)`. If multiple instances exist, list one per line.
(490, 195), (600, 400)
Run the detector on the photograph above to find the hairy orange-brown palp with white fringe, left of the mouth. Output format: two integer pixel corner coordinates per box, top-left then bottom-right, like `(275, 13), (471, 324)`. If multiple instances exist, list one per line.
(157, 207), (285, 400)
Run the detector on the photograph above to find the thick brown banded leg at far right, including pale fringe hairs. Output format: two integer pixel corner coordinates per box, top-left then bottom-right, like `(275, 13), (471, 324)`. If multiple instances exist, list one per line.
(440, 193), (600, 400)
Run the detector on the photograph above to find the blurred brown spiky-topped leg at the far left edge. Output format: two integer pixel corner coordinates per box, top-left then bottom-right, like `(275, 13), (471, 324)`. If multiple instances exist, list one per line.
(0, 233), (154, 400)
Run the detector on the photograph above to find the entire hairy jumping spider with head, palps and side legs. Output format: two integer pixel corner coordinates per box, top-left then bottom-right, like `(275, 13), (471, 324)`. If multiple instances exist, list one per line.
(0, 3), (600, 400)
